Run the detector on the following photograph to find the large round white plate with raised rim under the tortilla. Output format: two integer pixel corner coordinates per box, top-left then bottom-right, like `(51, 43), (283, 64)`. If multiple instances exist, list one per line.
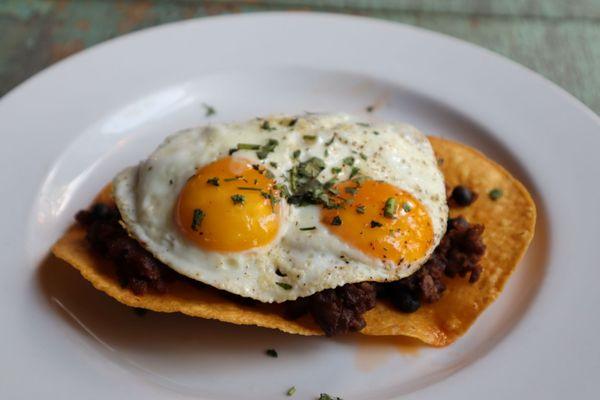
(0, 13), (600, 400)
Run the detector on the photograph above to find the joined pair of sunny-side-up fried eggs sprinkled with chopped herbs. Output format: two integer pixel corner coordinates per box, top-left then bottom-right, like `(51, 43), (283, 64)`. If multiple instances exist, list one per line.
(113, 114), (448, 302)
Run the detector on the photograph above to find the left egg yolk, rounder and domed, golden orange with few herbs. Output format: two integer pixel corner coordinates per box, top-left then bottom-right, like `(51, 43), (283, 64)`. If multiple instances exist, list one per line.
(175, 157), (279, 252)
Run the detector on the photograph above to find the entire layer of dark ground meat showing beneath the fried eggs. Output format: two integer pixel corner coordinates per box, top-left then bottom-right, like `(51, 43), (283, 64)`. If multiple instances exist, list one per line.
(76, 204), (485, 336)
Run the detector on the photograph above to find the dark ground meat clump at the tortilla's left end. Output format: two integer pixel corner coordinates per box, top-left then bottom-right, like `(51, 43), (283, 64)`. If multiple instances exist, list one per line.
(75, 203), (175, 295)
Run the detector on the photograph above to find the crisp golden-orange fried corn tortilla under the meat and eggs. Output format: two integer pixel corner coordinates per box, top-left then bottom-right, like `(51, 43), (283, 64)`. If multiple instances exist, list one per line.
(52, 137), (536, 346)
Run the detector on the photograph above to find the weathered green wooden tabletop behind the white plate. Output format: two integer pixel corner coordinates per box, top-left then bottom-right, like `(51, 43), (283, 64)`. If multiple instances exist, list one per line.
(0, 0), (600, 113)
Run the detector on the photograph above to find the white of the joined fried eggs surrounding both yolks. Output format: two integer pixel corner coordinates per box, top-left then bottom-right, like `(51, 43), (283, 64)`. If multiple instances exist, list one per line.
(113, 114), (448, 302)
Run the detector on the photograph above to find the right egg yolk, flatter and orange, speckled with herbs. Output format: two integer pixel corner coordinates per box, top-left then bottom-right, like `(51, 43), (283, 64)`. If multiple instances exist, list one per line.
(321, 180), (433, 264)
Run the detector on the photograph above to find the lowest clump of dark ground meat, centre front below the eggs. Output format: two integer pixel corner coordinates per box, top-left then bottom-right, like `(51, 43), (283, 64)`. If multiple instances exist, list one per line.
(286, 282), (377, 336)
